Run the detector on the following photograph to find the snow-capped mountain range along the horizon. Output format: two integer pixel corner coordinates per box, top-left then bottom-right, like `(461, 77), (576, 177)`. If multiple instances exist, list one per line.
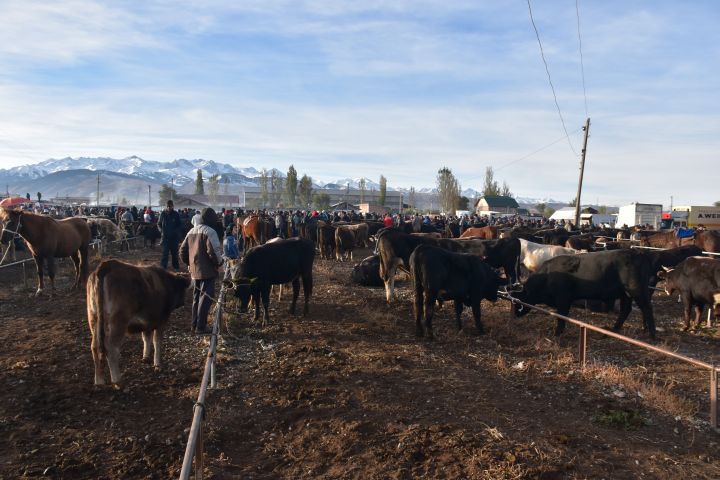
(0, 156), (562, 205)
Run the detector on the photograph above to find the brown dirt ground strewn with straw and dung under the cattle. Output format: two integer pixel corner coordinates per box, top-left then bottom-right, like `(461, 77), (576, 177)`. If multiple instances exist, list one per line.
(0, 246), (720, 479)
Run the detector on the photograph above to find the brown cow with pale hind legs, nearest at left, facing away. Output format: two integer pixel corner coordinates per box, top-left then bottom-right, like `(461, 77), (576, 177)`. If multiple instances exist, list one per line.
(86, 260), (190, 385)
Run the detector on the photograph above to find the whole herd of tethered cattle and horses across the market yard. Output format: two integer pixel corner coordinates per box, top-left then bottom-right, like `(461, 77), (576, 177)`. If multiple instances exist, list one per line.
(0, 208), (720, 384)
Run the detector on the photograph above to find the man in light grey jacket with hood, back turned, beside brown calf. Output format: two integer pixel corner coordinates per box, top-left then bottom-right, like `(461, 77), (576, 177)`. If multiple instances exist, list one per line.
(180, 207), (223, 335)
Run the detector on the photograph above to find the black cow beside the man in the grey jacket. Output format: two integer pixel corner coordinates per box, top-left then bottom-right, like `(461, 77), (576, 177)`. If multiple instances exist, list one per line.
(233, 237), (315, 325)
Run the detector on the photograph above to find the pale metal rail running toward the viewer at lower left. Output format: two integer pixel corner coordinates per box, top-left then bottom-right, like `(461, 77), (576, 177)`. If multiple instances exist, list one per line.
(180, 274), (230, 480)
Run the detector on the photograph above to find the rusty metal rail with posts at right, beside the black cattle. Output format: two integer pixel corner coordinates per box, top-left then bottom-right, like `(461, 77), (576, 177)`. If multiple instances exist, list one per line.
(498, 292), (718, 429)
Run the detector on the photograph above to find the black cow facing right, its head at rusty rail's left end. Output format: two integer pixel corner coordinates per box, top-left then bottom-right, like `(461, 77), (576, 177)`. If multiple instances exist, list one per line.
(410, 245), (500, 339)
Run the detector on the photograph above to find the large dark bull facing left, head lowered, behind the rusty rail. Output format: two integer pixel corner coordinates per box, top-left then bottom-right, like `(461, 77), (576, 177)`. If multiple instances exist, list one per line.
(513, 250), (655, 338)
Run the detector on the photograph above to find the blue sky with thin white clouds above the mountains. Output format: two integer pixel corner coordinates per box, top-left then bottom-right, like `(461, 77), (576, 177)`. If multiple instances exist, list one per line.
(0, 0), (720, 207)
